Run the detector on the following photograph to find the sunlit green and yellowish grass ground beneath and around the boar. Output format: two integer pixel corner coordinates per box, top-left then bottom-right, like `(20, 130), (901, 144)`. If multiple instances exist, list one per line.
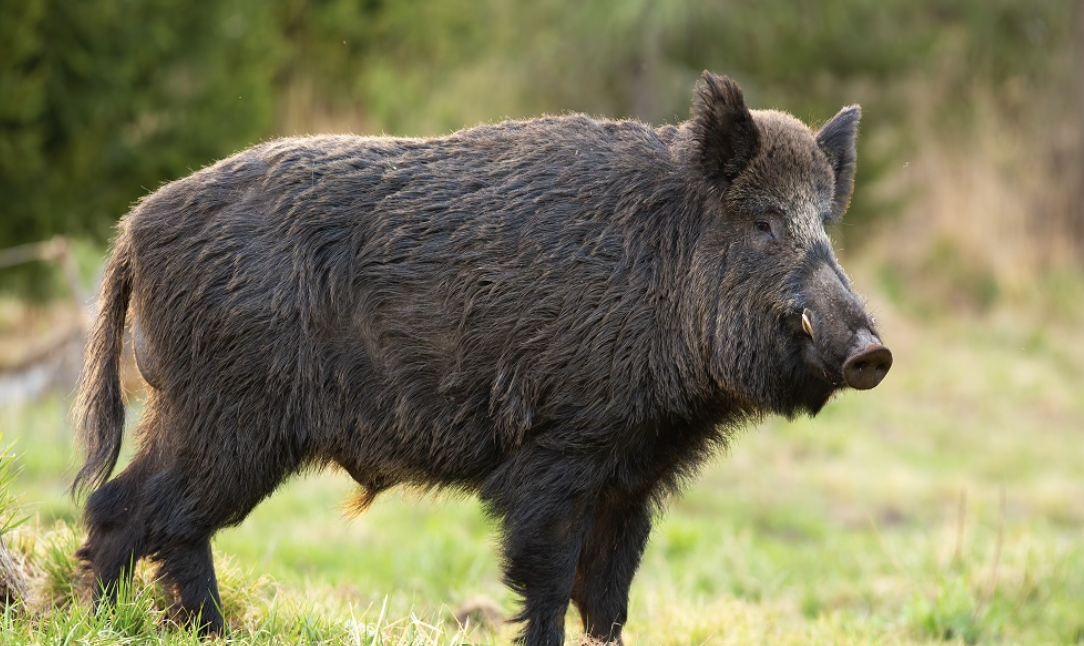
(0, 290), (1084, 646)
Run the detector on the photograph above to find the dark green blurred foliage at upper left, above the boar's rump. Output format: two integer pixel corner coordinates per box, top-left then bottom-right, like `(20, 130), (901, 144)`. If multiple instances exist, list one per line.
(0, 0), (281, 245)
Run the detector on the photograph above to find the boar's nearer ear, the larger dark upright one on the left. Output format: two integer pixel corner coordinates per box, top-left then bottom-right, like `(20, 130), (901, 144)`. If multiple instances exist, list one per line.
(692, 72), (760, 190)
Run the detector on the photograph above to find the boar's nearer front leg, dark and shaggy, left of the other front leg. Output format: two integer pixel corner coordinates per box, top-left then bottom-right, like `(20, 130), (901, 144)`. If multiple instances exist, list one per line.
(481, 445), (605, 646)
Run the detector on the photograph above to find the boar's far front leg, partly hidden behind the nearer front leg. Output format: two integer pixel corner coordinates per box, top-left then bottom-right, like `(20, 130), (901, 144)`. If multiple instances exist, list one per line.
(572, 490), (651, 644)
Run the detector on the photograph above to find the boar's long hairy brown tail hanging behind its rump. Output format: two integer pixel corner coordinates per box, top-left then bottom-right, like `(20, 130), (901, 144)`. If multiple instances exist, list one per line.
(72, 234), (132, 495)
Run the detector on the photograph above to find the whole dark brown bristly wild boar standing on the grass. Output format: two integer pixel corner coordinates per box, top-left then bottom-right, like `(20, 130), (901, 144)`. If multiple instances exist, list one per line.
(76, 73), (888, 646)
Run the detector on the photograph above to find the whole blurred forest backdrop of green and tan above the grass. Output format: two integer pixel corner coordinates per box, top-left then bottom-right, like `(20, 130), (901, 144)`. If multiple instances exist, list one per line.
(0, 0), (1084, 309)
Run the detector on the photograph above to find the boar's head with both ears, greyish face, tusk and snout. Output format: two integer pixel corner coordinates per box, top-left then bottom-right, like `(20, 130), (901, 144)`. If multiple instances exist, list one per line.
(684, 73), (892, 415)
